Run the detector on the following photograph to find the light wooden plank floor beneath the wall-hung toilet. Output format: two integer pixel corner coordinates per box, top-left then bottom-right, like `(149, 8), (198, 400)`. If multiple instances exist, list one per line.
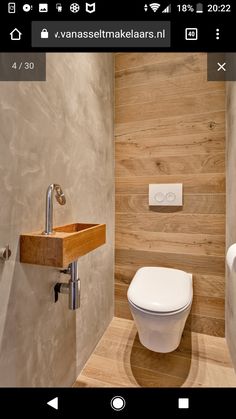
(74, 317), (236, 387)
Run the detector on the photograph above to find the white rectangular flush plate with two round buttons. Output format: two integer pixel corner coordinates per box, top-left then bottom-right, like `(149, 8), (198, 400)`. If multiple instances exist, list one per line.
(149, 183), (183, 207)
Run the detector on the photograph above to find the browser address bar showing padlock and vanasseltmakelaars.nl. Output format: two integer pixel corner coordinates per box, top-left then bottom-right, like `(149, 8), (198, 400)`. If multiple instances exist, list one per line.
(32, 21), (171, 48)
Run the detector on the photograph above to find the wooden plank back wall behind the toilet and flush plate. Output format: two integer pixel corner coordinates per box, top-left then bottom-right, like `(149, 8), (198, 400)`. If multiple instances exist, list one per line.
(115, 53), (225, 336)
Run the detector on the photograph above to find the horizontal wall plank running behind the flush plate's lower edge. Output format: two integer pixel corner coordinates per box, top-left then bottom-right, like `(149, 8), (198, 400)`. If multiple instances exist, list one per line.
(116, 193), (225, 217)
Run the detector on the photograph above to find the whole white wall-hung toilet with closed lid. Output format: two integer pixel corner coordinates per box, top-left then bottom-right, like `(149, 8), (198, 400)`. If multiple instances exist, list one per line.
(128, 267), (193, 352)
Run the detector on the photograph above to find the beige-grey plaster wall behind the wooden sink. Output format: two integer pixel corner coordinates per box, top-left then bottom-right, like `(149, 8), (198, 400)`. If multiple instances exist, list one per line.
(0, 54), (114, 386)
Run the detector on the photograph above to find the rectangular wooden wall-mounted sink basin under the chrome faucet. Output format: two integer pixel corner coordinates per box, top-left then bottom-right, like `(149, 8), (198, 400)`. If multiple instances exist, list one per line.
(20, 223), (106, 268)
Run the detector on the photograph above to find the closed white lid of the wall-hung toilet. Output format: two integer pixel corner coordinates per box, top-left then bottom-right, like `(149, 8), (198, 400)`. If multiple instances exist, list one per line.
(128, 267), (193, 313)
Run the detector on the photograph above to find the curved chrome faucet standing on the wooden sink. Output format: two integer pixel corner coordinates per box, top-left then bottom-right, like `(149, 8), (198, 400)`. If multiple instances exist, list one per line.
(44, 183), (66, 234)
